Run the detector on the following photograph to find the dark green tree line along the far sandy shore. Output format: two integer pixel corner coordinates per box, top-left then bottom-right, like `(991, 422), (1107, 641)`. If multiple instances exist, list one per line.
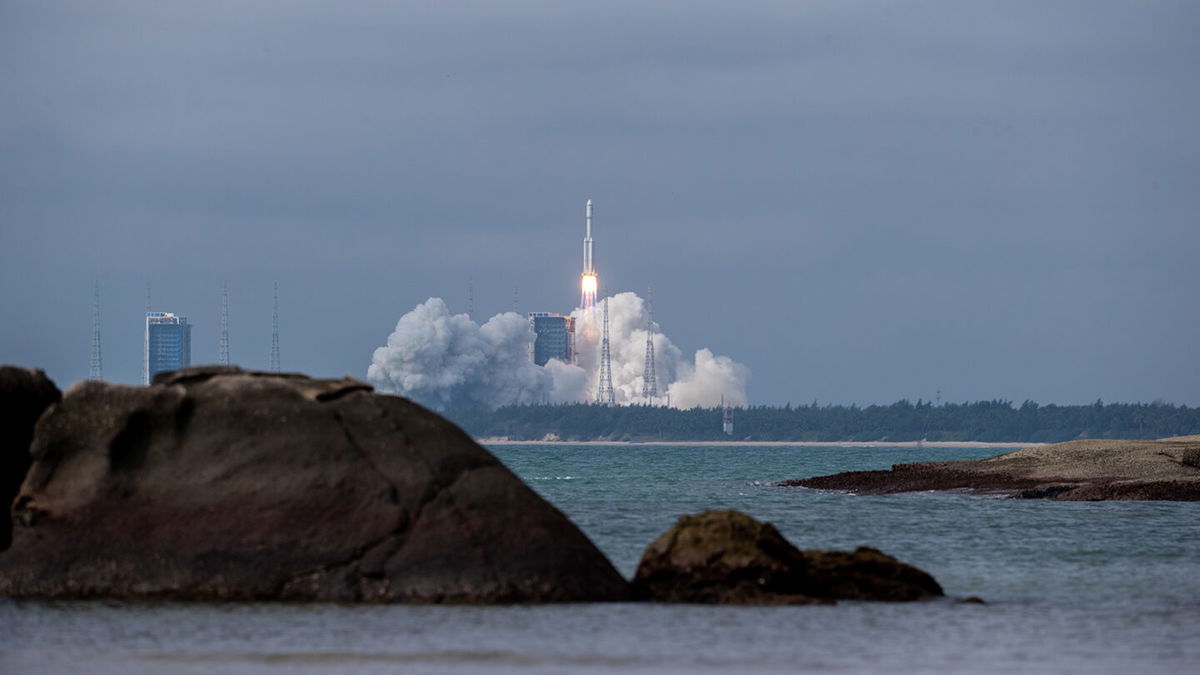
(445, 400), (1200, 442)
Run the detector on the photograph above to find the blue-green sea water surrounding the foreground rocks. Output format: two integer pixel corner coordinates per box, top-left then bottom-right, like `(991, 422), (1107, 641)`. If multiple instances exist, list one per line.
(0, 444), (1200, 674)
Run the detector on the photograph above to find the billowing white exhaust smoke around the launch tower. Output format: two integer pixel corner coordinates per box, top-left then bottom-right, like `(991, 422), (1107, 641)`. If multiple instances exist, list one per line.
(367, 293), (750, 410)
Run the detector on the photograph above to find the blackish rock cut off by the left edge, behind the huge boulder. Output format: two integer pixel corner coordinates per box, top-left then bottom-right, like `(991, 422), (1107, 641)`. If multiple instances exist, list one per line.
(0, 365), (62, 551)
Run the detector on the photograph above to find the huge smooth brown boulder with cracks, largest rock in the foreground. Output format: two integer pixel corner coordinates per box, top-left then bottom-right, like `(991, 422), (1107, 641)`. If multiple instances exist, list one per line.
(0, 366), (629, 603)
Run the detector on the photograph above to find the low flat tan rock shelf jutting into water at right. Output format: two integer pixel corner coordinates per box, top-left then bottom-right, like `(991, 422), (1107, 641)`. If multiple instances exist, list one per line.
(782, 436), (1200, 501)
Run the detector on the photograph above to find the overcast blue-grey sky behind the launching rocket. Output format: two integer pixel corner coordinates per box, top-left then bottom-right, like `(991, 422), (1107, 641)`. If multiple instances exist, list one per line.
(0, 0), (1200, 406)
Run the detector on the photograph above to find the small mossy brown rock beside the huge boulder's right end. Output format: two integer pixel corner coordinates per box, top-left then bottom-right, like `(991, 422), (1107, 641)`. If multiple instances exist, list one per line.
(634, 510), (942, 604)
